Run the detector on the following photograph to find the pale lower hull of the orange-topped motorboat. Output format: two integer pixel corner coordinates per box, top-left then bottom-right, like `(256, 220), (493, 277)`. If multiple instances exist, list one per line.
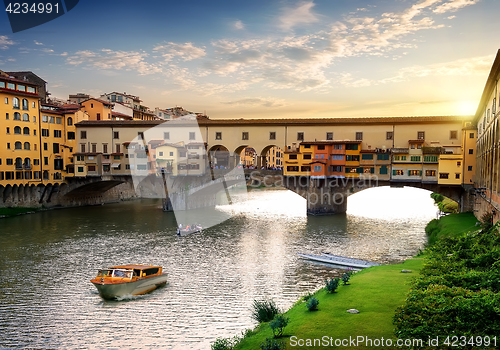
(91, 274), (167, 299)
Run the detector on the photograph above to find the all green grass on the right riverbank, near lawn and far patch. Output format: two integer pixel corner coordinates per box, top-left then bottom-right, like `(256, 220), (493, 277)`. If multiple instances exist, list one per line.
(229, 213), (477, 350)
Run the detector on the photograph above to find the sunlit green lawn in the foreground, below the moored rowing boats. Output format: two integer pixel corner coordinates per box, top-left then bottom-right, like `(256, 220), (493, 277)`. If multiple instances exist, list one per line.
(236, 259), (424, 350)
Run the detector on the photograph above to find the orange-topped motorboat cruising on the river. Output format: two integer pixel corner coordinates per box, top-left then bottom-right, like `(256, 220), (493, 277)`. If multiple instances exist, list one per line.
(90, 265), (167, 299)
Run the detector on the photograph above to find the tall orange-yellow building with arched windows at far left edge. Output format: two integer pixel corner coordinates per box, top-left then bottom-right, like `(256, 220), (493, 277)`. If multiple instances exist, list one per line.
(0, 71), (44, 186)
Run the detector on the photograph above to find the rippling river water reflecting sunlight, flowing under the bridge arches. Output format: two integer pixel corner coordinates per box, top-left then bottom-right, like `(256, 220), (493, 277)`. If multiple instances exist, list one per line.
(0, 188), (436, 349)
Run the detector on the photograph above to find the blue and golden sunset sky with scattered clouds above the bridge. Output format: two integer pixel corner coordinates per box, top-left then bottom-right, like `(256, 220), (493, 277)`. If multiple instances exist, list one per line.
(0, 0), (500, 119)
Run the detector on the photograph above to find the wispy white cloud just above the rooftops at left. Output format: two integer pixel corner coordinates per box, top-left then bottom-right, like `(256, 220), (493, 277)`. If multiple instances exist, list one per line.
(66, 49), (161, 75)
